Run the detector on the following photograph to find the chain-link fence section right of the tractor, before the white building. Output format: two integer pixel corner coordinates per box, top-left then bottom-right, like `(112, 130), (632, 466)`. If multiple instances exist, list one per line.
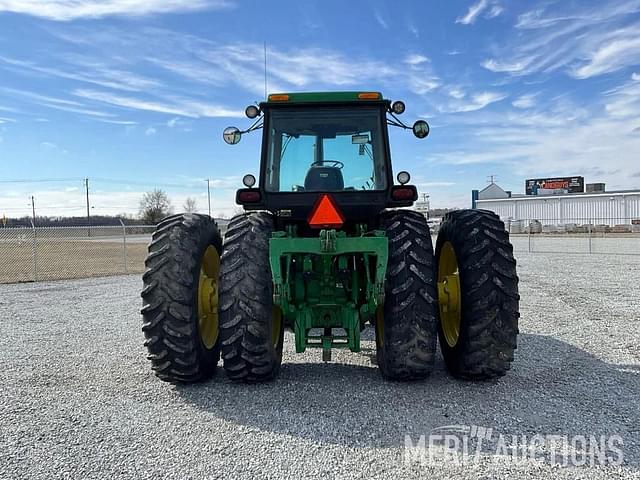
(505, 218), (640, 255)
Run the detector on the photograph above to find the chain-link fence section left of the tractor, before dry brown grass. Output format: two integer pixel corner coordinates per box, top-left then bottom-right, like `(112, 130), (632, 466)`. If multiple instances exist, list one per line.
(0, 225), (155, 283)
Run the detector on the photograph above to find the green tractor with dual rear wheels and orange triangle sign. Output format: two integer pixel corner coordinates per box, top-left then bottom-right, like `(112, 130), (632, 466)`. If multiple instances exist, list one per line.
(142, 92), (519, 382)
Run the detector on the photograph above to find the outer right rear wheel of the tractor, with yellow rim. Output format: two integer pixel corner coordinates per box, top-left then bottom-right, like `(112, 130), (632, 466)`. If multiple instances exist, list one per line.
(436, 210), (520, 379)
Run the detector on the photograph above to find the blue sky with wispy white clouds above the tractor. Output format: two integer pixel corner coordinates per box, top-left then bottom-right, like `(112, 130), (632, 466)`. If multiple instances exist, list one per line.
(0, 0), (640, 216)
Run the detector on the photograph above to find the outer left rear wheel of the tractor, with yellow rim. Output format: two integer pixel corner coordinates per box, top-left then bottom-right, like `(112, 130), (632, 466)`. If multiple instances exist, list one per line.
(141, 214), (222, 383)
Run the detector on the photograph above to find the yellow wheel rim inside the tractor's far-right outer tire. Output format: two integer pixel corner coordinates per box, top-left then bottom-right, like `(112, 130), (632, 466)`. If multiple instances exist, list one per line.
(438, 242), (462, 347)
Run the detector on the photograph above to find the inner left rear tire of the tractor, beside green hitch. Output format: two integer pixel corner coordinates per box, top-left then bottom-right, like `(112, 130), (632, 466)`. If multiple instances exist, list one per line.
(220, 212), (284, 383)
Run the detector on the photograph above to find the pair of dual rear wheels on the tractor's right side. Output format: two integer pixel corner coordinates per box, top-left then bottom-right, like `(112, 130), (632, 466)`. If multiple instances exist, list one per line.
(376, 210), (520, 380)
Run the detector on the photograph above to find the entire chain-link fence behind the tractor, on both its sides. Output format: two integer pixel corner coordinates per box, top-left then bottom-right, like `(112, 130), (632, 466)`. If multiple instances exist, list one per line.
(0, 215), (640, 283)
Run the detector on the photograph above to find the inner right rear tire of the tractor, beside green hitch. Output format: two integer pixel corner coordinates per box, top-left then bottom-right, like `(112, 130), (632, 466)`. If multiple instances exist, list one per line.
(376, 210), (438, 380)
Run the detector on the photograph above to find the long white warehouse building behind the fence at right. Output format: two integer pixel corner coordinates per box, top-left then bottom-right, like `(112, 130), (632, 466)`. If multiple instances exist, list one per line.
(473, 183), (640, 231)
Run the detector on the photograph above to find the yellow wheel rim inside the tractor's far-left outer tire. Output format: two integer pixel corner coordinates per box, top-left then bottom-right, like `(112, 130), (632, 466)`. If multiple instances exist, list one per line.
(198, 245), (220, 349)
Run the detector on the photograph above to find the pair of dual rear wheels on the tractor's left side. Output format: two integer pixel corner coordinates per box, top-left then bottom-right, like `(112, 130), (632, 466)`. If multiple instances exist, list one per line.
(142, 213), (284, 383)
